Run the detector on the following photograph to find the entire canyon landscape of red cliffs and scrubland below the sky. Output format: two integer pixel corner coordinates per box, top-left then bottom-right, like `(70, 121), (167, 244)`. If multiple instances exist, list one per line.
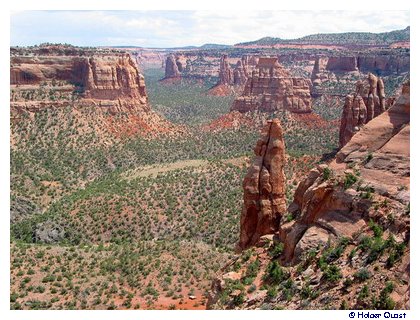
(10, 23), (410, 310)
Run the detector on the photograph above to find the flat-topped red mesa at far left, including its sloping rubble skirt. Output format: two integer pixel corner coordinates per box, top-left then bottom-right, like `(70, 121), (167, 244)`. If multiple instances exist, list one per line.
(10, 46), (183, 138)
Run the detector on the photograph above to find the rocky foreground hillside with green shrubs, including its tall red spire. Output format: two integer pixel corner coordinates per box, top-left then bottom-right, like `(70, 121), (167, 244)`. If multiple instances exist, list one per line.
(208, 82), (410, 309)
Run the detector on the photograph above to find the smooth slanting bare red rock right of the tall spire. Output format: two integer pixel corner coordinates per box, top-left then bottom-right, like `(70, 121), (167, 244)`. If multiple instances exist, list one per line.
(280, 83), (410, 263)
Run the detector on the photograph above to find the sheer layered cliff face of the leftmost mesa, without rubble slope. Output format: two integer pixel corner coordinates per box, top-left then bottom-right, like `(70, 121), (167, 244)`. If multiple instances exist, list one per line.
(10, 50), (150, 113)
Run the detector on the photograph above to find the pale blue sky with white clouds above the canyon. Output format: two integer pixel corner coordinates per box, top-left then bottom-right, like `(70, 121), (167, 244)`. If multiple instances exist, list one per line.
(10, 10), (410, 48)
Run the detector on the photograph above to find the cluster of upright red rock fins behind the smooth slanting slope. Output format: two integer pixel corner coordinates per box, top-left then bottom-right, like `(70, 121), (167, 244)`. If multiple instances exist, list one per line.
(339, 73), (386, 147)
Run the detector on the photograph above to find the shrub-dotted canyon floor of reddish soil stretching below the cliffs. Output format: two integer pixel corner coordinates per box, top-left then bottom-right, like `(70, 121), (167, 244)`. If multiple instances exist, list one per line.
(10, 53), (409, 309)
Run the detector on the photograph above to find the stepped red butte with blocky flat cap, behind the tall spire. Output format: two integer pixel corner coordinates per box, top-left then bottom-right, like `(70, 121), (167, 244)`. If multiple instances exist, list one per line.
(231, 57), (312, 113)
